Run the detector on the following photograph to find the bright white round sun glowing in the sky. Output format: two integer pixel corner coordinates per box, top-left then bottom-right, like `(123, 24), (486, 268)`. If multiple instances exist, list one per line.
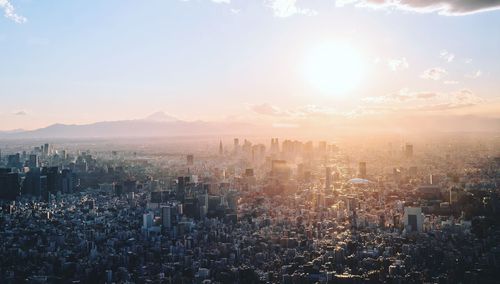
(304, 42), (366, 95)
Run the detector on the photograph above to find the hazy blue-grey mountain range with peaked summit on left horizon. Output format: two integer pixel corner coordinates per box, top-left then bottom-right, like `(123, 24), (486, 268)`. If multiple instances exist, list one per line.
(0, 115), (264, 139)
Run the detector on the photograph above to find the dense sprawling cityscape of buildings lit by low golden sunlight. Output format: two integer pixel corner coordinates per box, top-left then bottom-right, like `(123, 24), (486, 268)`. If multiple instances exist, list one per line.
(0, 136), (500, 283)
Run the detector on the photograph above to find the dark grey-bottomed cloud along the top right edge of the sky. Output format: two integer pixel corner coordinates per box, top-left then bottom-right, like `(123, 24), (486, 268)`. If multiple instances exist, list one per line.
(336, 0), (500, 16)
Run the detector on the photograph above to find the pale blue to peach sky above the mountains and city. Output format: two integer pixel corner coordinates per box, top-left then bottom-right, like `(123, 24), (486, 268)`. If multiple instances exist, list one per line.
(0, 0), (500, 130)
